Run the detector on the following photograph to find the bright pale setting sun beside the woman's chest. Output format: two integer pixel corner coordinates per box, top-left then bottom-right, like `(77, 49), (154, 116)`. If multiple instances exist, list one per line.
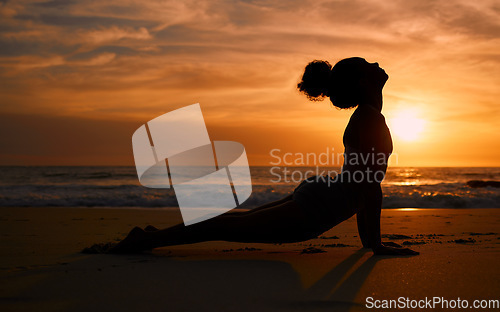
(389, 110), (425, 141)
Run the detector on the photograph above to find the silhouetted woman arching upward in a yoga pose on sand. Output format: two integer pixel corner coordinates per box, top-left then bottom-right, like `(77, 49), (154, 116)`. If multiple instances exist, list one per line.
(110, 57), (418, 255)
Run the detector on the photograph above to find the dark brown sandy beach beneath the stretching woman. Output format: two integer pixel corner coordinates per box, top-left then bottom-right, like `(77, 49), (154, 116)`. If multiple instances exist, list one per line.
(0, 207), (500, 311)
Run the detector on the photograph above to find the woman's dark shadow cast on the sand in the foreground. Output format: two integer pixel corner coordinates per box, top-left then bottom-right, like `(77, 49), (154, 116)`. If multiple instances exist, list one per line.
(0, 250), (408, 311)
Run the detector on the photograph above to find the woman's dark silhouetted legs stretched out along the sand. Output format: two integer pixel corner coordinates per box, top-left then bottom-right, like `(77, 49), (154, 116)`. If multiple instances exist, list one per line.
(112, 200), (326, 252)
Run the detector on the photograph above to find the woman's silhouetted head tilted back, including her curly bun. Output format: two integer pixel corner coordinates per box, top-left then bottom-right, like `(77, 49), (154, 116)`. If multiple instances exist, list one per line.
(297, 57), (389, 108)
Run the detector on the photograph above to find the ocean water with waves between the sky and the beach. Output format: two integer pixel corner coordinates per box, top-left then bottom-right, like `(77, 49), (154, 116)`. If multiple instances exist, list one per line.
(0, 166), (500, 208)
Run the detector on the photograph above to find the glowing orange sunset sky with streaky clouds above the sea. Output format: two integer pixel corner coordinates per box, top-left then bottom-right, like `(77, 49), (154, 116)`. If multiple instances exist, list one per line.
(0, 0), (500, 166)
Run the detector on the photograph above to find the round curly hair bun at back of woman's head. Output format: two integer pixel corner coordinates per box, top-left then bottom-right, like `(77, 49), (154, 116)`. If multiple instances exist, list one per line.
(297, 60), (332, 101)
